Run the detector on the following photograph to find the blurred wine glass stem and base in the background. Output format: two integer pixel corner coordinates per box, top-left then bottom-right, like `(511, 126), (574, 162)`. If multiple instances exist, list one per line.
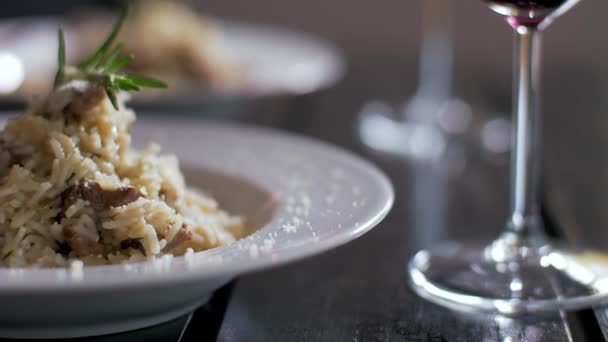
(357, 0), (471, 162)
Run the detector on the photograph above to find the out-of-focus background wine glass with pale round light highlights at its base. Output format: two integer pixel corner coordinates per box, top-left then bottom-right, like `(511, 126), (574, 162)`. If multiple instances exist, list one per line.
(358, 0), (511, 166)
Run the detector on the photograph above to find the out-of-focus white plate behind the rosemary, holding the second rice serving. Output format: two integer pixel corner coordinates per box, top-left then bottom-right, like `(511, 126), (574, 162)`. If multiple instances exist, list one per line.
(0, 17), (345, 112)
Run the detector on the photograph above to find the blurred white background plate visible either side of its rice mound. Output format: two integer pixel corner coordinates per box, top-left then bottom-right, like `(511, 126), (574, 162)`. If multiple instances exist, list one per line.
(0, 17), (345, 99)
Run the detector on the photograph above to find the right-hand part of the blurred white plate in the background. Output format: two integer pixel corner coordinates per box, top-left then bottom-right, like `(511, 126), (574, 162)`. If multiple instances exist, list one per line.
(218, 21), (345, 95)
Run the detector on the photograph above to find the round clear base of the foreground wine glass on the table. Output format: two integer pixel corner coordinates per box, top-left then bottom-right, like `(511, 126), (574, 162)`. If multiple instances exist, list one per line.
(408, 242), (608, 315)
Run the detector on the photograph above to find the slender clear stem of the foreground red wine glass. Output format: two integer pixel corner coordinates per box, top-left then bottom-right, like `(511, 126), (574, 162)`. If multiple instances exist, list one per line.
(508, 27), (542, 239)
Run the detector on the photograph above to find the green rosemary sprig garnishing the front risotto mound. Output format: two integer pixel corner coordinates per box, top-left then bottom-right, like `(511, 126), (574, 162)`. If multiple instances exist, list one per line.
(54, 8), (167, 110)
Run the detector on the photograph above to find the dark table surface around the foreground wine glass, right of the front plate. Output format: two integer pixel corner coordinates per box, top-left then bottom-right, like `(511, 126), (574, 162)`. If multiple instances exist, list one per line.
(209, 58), (608, 341)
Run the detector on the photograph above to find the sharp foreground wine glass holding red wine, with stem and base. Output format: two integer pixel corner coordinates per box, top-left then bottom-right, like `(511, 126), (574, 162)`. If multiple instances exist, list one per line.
(408, 0), (608, 315)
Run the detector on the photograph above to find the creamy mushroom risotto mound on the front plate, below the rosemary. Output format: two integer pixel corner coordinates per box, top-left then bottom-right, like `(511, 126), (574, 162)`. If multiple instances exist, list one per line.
(0, 80), (243, 267)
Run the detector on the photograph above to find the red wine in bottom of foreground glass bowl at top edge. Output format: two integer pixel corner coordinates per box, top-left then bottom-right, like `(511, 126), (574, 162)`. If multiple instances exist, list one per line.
(484, 0), (568, 28)
